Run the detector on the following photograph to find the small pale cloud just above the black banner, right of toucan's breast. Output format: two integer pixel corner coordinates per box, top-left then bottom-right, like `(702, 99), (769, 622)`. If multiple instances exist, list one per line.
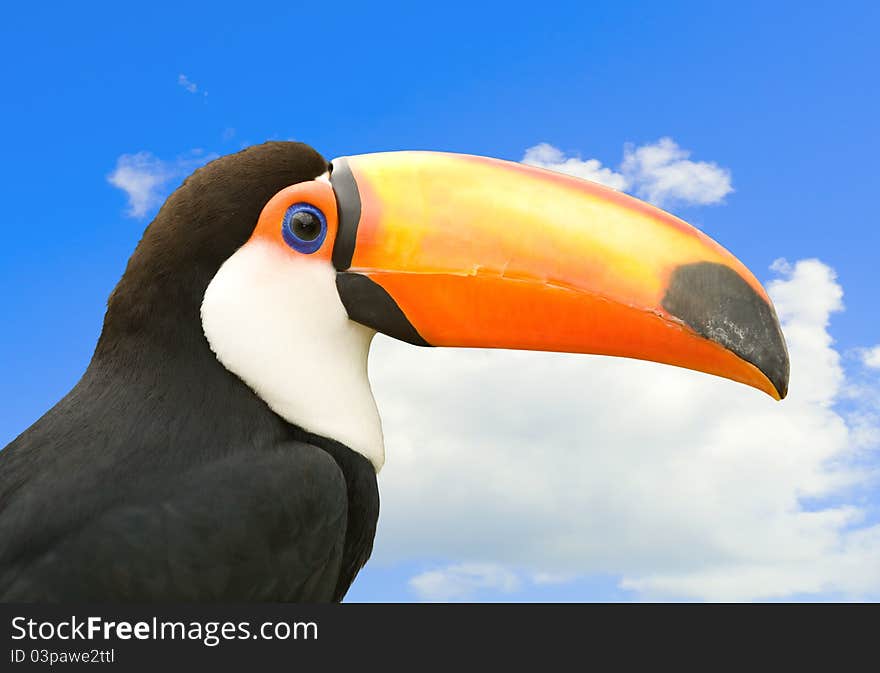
(409, 563), (520, 602)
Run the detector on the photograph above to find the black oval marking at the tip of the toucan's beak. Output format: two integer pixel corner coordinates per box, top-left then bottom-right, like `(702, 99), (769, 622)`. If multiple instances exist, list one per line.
(662, 262), (789, 397)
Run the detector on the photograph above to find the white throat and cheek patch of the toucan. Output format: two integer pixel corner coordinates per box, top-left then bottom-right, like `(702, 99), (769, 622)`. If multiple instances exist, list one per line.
(202, 240), (385, 472)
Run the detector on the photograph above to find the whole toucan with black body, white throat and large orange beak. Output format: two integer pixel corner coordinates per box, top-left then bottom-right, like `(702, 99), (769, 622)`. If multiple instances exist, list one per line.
(0, 142), (789, 602)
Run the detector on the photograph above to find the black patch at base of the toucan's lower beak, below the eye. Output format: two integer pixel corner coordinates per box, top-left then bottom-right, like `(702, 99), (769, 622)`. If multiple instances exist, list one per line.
(336, 273), (431, 346)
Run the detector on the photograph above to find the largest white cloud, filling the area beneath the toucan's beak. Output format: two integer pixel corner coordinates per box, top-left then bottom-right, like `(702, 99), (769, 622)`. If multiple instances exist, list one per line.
(370, 260), (880, 600)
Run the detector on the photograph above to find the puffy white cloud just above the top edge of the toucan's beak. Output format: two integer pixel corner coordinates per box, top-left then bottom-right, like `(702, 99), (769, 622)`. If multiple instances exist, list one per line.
(522, 138), (733, 206)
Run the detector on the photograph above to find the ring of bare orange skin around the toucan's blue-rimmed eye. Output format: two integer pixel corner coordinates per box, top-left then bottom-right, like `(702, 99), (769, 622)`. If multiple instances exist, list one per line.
(250, 180), (339, 262)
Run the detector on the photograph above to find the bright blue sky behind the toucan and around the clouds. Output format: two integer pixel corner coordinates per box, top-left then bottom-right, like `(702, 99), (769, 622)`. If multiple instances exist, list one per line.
(0, 2), (880, 600)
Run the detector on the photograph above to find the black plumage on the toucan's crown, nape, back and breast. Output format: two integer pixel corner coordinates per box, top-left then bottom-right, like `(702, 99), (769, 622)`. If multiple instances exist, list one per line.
(0, 143), (379, 601)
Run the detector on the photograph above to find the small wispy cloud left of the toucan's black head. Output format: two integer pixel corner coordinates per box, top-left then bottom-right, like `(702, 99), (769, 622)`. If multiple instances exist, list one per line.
(107, 150), (217, 218)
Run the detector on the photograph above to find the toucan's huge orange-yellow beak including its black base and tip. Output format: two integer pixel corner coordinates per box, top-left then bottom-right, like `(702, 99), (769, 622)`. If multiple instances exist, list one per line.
(330, 152), (789, 399)
